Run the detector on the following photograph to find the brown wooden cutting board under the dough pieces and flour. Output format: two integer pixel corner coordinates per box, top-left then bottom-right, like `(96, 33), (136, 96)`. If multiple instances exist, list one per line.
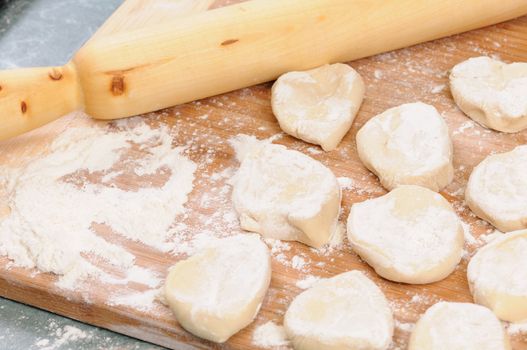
(0, 0), (527, 350)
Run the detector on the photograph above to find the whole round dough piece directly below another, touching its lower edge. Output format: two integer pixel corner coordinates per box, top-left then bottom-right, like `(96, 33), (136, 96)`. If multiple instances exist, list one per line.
(348, 185), (464, 284)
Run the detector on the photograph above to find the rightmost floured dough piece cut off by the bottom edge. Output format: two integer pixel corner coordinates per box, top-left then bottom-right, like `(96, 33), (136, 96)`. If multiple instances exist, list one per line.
(408, 302), (511, 350)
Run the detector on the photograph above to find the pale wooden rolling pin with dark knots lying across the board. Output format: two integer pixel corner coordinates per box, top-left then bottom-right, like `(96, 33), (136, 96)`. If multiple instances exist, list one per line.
(0, 0), (527, 139)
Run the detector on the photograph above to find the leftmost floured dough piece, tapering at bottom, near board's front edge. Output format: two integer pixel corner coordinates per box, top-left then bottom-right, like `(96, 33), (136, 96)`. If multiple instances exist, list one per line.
(165, 234), (271, 343)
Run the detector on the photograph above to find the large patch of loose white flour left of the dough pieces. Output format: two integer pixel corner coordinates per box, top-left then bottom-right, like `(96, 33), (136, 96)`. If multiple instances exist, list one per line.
(0, 118), (196, 289)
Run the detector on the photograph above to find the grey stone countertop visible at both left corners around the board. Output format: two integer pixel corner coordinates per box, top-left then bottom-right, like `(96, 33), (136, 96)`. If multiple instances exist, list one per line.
(0, 0), (161, 350)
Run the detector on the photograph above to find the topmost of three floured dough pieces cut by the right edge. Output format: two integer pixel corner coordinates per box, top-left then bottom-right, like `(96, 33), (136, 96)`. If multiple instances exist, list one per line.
(450, 57), (527, 132)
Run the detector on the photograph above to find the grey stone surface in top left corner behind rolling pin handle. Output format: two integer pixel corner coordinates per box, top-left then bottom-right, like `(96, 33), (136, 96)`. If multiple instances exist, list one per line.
(0, 0), (122, 68)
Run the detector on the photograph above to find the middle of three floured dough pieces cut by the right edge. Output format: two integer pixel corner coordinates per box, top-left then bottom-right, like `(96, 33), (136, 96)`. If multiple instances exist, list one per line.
(465, 145), (527, 232)
